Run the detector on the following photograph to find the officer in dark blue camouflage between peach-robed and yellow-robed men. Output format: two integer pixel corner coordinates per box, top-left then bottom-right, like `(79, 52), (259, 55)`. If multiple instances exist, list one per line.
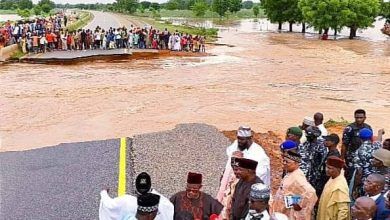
(298, 126), (327, 187)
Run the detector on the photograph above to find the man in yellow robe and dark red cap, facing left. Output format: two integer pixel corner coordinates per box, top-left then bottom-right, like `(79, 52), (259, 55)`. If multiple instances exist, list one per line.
(317, 156), (351, 220)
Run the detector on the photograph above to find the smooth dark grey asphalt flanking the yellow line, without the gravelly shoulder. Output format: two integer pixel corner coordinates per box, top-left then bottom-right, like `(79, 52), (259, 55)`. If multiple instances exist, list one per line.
(0, 139), (133, 220)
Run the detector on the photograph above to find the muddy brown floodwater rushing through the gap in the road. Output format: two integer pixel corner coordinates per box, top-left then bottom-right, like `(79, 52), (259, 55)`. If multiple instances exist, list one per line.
(0, 19), (390, 151)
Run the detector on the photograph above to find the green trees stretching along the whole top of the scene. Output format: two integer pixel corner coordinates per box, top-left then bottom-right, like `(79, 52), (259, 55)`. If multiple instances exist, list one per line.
(0, 0), (390, 39)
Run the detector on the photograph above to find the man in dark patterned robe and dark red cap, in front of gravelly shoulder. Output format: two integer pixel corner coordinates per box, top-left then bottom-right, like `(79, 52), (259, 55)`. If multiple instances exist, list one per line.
(170, 172), (223, 220)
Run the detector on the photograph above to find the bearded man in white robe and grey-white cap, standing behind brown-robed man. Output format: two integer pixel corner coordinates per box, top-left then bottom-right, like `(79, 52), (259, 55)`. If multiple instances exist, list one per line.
(217, 126), (270, 201)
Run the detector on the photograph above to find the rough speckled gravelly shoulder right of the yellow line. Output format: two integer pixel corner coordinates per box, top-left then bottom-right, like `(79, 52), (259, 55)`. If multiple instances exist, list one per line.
(132, 124), (230, 197)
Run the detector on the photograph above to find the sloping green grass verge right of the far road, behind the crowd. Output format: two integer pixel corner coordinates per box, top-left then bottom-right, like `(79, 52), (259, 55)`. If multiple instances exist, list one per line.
(134, 16), (218, 41)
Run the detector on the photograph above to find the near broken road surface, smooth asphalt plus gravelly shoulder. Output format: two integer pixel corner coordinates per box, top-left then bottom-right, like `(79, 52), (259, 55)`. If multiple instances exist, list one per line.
(0, 124), (230, 220)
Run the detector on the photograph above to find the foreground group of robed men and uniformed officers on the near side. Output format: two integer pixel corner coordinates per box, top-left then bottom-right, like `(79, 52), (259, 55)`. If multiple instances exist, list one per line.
(99, 109), (390, 220)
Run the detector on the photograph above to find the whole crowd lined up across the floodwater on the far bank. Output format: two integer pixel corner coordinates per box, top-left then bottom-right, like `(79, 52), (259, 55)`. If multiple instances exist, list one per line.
(0, 19), (206, 53)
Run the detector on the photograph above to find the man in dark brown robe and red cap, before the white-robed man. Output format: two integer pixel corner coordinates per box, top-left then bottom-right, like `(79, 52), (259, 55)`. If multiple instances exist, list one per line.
(230, 158), (263, 219)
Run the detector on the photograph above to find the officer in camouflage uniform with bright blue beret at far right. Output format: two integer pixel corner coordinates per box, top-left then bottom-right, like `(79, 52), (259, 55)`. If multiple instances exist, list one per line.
(353, 128), (382, 198)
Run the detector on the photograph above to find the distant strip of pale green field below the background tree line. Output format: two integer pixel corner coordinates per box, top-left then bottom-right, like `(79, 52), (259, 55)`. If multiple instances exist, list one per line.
(134, 9), (265, 19)
